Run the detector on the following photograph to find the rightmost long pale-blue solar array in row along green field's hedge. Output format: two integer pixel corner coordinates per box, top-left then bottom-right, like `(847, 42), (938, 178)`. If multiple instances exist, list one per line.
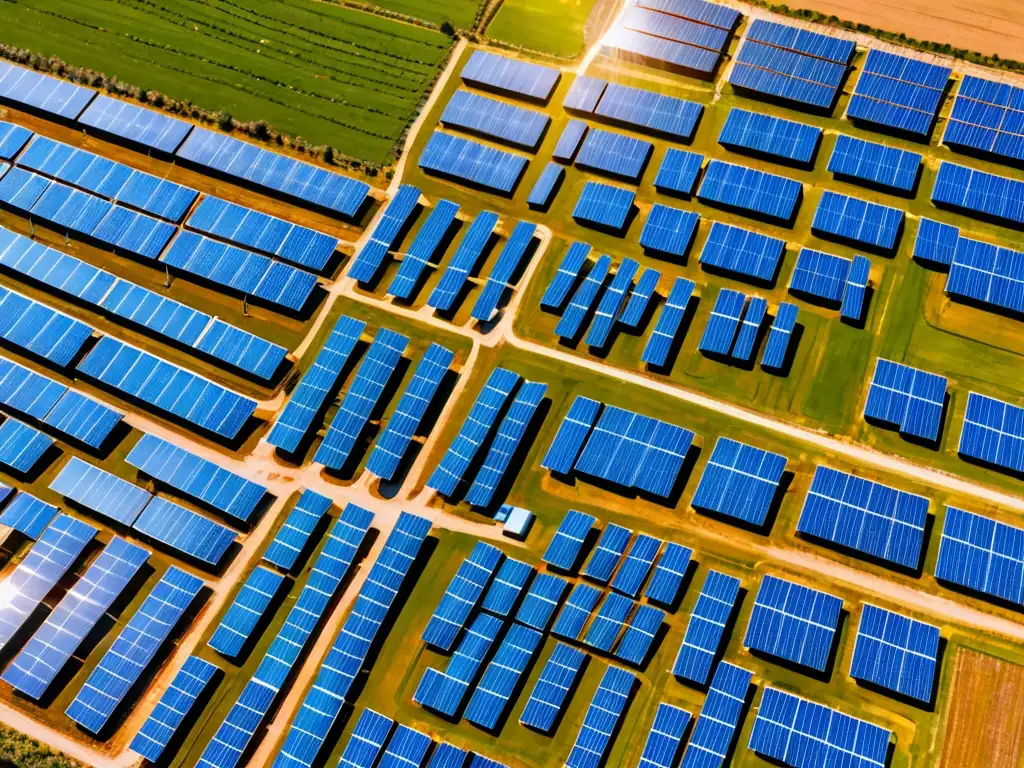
(176, 127), (370, 218)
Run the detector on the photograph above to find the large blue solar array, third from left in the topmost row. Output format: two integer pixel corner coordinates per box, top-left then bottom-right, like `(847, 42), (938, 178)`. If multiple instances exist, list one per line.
(846, 48), (951, 138)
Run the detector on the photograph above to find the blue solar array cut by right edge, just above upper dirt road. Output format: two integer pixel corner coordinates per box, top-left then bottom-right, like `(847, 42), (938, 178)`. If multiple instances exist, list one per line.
(957, 392), (1024, 479)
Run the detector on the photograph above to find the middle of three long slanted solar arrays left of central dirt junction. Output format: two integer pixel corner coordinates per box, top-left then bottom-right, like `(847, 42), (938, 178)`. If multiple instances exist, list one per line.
(313, 328), (409, 471)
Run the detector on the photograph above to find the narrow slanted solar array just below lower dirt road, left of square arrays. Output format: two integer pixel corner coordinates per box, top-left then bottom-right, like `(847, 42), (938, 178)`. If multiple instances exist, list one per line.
(672, 570), (739, 685)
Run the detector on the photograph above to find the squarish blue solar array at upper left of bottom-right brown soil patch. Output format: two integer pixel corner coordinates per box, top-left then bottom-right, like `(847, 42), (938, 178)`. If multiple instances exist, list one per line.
(850, 603), (939, 703)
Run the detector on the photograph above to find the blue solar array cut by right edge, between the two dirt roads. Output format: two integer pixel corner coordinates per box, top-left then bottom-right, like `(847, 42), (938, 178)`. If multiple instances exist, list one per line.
(935, 506), (1024, 605)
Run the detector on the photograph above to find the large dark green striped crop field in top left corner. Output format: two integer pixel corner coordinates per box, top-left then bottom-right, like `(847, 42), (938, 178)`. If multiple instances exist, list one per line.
(0, 0), (452, 163)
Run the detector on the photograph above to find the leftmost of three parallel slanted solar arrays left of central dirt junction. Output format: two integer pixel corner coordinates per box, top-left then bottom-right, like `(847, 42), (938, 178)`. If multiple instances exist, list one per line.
(266, 314), (367, 454)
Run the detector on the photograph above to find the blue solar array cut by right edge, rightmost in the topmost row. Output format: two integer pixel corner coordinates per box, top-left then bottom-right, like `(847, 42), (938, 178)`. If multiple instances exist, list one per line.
(942, 75), (1024, 162)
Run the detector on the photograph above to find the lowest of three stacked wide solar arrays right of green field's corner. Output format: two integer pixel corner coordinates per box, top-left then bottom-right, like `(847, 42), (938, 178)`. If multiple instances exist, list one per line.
(420, 131), (527, 195)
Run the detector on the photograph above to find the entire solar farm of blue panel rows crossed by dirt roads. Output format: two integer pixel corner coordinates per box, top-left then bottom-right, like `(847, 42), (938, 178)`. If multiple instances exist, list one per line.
(0, 0), (1024, 768)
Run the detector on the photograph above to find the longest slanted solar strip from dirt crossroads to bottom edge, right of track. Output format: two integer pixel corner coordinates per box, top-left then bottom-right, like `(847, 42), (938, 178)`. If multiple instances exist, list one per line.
(272, 512), (430, 768)
